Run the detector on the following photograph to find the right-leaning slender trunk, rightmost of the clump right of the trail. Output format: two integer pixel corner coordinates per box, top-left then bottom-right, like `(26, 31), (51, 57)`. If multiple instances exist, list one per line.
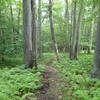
(75, 1), (83, 59)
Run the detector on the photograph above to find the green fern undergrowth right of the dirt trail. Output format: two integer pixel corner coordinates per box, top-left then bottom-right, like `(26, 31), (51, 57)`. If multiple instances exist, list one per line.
(53, 54), (100, 100)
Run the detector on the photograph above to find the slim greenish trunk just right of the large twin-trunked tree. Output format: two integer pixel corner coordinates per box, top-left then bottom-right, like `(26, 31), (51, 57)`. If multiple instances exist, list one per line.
(38, 0), (42, 57)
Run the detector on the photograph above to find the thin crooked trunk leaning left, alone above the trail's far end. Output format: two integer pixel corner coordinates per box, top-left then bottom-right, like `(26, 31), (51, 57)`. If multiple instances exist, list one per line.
(49, 0), (59, 60)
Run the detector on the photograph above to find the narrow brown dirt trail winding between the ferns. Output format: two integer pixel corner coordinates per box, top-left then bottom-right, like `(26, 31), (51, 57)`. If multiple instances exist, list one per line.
(37, 59), (64, 100)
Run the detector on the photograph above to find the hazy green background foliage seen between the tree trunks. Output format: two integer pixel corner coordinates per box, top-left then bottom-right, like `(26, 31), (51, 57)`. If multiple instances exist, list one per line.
(0, 0), (98, 56)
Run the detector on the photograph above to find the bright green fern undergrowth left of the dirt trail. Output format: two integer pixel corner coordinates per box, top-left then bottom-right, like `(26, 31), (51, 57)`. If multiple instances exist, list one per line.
(0, 65), (44, 100)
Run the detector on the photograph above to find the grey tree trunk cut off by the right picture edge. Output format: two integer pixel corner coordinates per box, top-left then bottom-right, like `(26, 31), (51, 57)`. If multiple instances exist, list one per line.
(91, 1), (100, 79)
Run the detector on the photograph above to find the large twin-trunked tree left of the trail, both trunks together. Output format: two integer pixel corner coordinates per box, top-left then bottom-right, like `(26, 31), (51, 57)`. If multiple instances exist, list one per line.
(23, 0), (37, 68)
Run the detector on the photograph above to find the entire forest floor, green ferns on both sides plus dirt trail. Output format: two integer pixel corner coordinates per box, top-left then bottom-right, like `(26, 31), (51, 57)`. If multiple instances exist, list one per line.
(0, 53), (100, 100)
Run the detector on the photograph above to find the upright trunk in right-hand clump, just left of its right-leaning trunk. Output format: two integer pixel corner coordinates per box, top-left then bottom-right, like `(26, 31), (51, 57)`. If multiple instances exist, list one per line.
(70, 0), (76, 59)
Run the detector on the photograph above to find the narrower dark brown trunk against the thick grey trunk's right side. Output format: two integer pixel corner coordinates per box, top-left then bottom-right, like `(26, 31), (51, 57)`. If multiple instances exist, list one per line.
(31, 0), (37, 67)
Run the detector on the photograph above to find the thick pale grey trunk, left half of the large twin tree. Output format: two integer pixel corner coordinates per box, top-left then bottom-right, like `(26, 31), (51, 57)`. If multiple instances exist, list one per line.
(23, 0), (33, 68)
